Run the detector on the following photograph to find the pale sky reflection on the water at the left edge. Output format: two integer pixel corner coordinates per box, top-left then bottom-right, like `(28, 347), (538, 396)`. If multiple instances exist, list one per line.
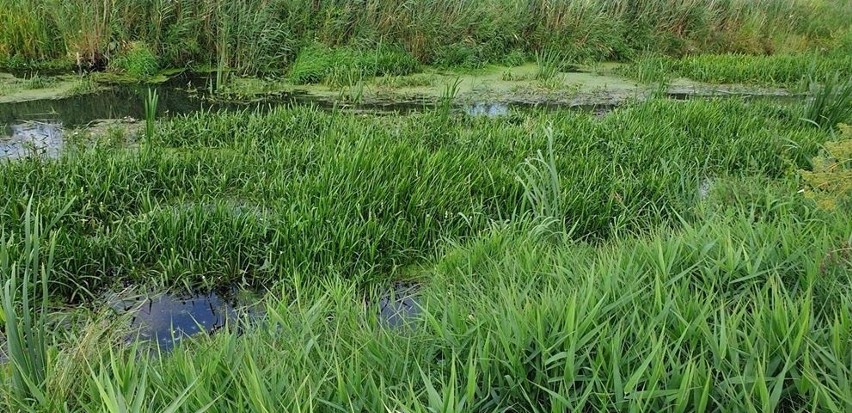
(0, 122), (62, 159)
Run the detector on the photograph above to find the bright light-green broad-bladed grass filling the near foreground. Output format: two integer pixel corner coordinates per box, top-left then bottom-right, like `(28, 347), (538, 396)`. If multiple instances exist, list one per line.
(1, 208), (852, 412)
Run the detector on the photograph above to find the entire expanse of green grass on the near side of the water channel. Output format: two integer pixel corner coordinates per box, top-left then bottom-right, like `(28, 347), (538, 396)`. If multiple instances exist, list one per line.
(0, 93), (852, 412)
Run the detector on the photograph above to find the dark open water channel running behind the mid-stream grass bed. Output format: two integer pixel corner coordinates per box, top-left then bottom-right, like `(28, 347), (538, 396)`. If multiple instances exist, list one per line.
(0, 74), (544, 159)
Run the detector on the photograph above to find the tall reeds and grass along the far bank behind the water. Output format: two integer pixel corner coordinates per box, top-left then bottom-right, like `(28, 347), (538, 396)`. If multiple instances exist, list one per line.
(0, 0), (852, 74)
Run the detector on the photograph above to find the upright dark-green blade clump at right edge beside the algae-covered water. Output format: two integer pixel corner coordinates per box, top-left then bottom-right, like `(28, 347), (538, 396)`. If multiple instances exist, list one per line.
(804, 72), (852, 128)
